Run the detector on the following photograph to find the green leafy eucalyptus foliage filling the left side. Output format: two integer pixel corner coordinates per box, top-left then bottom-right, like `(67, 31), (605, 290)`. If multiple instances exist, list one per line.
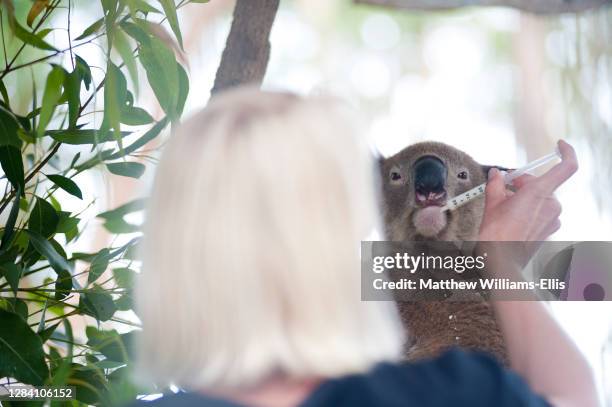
(0, 0), (197, 405)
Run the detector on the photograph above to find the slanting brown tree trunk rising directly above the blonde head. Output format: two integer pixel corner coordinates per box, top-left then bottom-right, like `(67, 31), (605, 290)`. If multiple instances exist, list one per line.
(212, 0), (279, 95)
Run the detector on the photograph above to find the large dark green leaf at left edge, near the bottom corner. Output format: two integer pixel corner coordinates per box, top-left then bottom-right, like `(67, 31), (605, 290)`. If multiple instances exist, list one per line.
(0, 310), (49, 386)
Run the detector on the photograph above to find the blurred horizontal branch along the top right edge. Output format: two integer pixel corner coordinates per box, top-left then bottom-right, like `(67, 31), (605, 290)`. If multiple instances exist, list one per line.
(354, 0), (612, 14)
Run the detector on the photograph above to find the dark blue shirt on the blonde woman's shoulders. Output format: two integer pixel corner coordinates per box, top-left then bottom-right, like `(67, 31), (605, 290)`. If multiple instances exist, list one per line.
(128, 349), (549, 407)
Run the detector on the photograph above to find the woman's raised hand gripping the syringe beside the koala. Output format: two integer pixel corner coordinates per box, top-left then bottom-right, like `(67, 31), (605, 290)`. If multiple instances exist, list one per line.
(479, 140), (578, 241)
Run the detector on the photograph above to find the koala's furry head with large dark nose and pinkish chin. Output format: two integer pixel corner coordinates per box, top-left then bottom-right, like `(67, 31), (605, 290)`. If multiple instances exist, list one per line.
(380, 142), (503, 241)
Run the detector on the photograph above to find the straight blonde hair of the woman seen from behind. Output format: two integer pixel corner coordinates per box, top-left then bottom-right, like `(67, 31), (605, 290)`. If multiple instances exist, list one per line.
(136, 88), (403, 389)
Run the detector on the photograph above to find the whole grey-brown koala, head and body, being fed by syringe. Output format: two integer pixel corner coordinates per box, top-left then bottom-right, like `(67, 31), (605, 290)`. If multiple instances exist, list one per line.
(380, 142), (507, 362)
